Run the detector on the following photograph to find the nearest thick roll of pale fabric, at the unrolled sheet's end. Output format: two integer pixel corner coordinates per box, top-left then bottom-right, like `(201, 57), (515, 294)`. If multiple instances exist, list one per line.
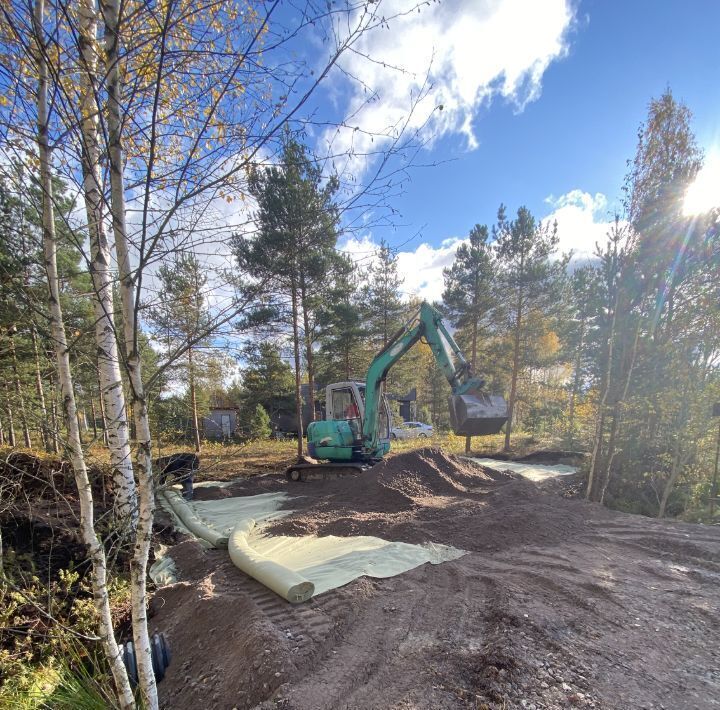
(228, 520), (315, 604)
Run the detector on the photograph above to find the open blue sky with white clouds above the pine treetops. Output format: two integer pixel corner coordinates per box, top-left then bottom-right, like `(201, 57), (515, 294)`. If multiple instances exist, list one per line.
(330, 0), (720, 297)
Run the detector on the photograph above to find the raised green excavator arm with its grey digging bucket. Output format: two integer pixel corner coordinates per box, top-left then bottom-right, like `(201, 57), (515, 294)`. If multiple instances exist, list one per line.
(362, 302), (507, 457)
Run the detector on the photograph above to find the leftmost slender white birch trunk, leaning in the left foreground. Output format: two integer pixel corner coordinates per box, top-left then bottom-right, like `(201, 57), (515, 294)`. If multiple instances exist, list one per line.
(33, 0), (135, 710)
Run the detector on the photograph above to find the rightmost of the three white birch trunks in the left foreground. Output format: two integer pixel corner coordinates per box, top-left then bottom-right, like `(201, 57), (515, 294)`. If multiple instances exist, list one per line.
(101, 0), (159, 710)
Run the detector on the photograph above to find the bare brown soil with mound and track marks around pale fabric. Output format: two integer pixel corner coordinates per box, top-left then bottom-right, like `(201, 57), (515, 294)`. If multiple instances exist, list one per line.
(151, 449), (720, 710)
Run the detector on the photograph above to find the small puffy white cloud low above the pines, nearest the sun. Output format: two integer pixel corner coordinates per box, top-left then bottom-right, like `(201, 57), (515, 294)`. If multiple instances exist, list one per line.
(543, 189), (612, 259)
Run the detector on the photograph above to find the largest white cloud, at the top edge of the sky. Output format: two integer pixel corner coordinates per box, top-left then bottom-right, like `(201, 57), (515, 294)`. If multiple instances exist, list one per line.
(326, 0), (574, 169)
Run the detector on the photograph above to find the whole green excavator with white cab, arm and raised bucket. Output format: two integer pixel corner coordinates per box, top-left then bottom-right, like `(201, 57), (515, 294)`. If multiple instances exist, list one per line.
(286, 302), (507, 481)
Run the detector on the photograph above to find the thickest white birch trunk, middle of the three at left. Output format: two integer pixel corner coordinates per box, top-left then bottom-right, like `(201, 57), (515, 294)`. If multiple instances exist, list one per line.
(79, 0), (137, 527)
